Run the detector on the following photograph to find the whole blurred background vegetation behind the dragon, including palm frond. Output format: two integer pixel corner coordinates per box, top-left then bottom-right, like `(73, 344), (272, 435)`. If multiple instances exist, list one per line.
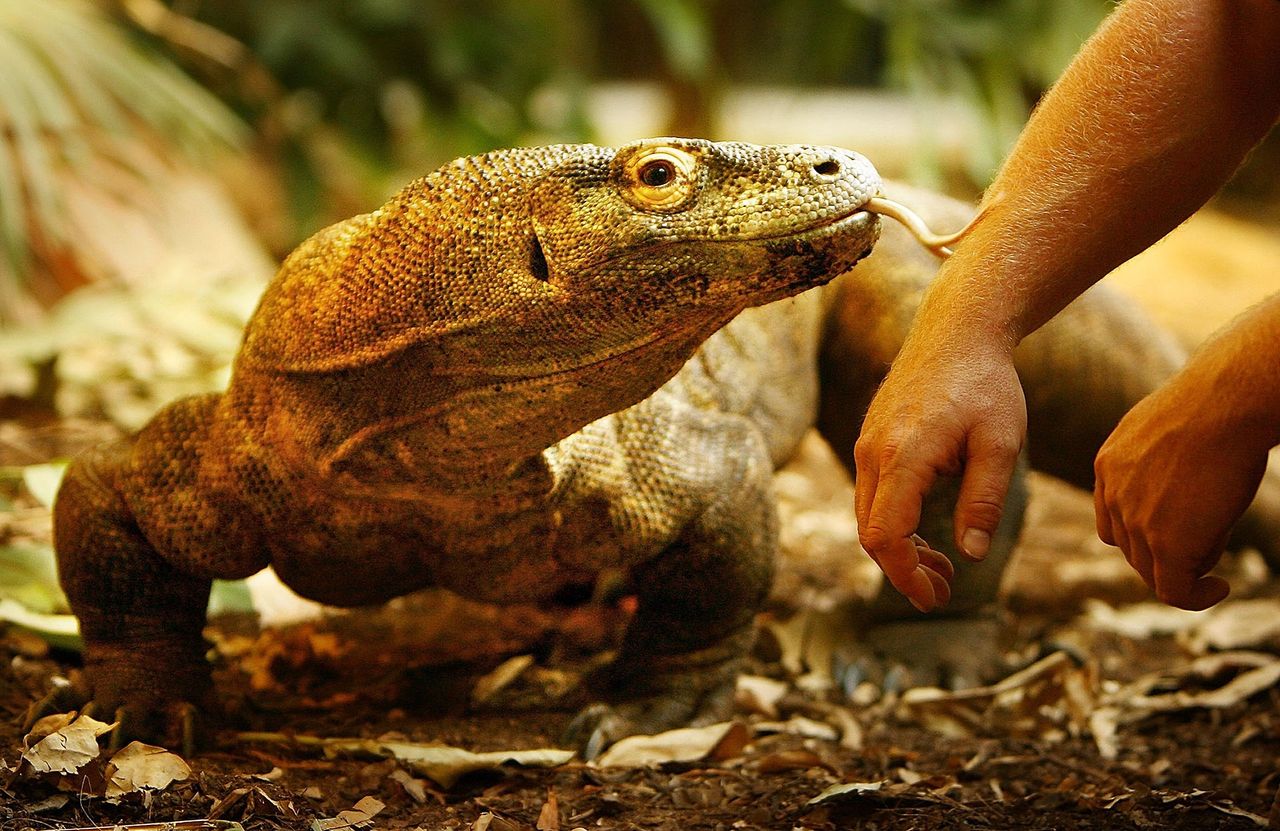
(0, 0), (1280, 428)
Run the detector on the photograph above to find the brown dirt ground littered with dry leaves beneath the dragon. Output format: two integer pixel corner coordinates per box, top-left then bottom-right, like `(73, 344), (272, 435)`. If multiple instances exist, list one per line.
(0, 208), (1280, 831)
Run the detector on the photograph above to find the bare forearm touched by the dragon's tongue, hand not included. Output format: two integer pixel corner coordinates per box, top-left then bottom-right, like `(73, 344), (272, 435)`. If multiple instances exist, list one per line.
(916, 0), (1280, 348)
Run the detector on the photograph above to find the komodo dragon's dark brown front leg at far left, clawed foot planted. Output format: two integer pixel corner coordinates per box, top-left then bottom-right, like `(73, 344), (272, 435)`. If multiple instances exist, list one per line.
(50, 396), (268, 754)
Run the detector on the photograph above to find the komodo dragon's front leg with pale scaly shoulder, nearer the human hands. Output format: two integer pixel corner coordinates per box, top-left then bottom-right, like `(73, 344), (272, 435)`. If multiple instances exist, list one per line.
(566, 389), (778, 758)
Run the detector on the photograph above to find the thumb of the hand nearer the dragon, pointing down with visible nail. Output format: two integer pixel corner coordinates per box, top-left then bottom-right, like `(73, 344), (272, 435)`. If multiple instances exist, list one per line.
(955, 429), (1021, 561)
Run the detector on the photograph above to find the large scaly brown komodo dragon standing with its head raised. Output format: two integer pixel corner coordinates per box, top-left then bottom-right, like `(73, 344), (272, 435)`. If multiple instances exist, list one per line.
(42, 138), (1280, 750)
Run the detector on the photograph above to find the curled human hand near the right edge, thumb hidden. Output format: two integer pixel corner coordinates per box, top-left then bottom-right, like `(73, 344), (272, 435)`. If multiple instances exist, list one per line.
(1093, 370), (1268, 611)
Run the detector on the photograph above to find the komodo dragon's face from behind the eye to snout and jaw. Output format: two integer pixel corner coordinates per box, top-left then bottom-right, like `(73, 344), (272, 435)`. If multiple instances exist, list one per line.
(532, 138), (879, 314)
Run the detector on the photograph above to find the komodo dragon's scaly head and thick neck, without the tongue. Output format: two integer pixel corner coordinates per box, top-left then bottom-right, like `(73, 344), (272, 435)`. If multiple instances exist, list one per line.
(238, 138), (879, 466)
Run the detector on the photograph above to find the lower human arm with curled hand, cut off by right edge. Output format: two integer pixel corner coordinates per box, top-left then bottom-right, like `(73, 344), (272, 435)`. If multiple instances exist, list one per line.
(1093, 294), (1280, 609)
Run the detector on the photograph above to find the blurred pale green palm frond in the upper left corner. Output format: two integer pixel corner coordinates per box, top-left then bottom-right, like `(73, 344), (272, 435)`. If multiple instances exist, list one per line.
(0, 0), (246, 325)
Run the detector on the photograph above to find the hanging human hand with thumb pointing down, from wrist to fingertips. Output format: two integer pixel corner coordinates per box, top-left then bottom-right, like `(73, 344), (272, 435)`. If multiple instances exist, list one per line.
(854, 328), (1027, 612)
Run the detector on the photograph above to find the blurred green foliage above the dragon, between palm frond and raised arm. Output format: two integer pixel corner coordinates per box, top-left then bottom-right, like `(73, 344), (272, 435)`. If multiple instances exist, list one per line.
(174, 0), (1111, 229)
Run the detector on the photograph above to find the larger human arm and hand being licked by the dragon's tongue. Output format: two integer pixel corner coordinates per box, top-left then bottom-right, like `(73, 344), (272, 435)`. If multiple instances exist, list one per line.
(855, 0), (1280, 608)
